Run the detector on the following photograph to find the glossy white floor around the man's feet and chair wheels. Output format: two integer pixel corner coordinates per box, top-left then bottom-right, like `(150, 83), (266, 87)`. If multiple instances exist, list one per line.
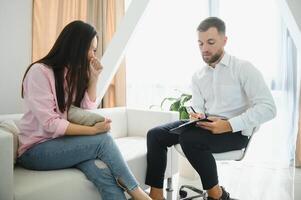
(168, 162), (301, 200)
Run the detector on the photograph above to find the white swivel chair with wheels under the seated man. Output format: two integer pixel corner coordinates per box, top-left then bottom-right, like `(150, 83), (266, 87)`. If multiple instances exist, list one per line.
(175, 129), (253, 200)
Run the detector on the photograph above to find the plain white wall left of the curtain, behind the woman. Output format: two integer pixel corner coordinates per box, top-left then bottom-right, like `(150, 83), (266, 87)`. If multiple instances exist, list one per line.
(0, 0), (32, 114)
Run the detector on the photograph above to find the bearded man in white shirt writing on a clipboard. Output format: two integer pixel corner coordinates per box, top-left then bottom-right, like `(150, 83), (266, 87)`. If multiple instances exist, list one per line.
(146, 17), (276, 200)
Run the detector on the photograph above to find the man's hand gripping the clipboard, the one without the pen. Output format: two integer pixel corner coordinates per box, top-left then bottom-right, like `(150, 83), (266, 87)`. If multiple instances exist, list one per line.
(196, 117), (232, 134)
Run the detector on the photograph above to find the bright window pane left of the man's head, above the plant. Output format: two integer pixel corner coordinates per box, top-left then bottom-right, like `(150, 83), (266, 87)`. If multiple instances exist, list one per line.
(126, 0), (208, 108)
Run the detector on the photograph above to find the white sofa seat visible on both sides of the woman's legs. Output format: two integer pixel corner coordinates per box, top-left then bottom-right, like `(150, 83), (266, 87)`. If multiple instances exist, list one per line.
(14, 137), (146, 200)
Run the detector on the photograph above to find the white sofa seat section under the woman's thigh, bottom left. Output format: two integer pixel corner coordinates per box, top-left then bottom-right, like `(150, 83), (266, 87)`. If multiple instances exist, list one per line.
(14, 166), (101, 200)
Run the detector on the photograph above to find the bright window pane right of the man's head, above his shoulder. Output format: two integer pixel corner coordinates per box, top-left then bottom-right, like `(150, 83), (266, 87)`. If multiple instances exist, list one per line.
(219, 0), (281, 86)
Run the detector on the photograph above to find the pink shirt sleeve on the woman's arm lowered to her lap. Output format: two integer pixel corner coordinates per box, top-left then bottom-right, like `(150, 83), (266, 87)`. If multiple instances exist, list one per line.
(23, 64), (69, 138)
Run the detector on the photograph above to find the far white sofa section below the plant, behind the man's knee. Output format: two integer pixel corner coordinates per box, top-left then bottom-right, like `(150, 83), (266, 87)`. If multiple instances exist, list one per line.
(127, 108), (179, 137)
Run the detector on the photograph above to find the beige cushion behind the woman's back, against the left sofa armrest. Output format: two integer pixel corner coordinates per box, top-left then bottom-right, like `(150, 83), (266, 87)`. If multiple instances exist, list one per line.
(0, 120), (20, 163)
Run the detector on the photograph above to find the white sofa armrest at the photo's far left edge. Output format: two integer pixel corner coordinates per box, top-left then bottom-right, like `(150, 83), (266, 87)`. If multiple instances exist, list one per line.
(0, 129), (14, 200)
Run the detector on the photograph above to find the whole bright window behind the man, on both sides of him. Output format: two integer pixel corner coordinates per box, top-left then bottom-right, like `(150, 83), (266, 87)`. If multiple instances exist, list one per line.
(126, 0), (297, 166)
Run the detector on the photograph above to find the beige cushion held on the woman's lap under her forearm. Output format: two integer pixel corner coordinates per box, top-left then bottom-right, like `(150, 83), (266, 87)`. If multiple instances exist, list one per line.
(68, 105), (105, 126)
